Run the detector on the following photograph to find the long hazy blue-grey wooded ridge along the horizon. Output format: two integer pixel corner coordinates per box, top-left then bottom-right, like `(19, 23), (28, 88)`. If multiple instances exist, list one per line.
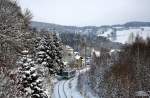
(31, 21), (150, 35)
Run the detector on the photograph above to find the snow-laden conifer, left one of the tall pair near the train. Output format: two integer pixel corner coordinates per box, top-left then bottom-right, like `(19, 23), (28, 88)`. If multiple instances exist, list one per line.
(35, 36), (54, 76)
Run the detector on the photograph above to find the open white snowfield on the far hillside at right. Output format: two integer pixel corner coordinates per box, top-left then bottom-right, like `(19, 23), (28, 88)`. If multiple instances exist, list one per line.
(97, 27), (150, 44)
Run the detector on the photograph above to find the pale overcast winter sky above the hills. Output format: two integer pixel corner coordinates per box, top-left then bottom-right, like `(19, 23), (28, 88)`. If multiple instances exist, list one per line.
(18, 0), (150, 26)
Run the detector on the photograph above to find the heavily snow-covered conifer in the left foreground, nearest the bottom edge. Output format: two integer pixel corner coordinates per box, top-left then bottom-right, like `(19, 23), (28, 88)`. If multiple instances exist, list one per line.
(18, 50), (48, 98)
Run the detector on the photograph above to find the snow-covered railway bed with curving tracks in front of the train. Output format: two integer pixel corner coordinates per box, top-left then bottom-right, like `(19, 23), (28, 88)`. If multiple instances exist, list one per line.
(52, 71), (89, 98)
